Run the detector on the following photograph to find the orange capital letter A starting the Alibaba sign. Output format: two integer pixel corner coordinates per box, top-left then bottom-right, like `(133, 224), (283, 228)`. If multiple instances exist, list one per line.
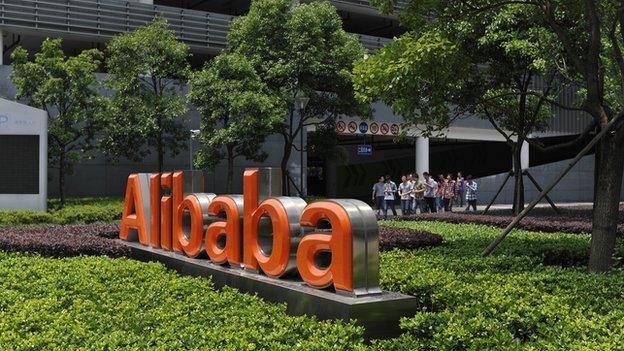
(119, 174), (149, 245)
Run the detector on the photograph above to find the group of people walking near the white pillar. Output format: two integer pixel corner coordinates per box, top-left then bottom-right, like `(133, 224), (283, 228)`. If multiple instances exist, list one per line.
(372, 172), (477, 218)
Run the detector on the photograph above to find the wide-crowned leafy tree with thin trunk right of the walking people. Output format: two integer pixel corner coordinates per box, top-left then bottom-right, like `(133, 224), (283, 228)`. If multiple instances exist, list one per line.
(355, 6), (557, 213)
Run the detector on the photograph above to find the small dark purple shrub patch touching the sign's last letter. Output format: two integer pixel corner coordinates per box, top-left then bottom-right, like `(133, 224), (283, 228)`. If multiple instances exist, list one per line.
(379, 225), (444, 251)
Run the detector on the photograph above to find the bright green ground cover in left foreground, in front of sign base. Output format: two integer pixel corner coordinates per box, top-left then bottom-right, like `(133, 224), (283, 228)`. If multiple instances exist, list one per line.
(0, 252), (363, 350)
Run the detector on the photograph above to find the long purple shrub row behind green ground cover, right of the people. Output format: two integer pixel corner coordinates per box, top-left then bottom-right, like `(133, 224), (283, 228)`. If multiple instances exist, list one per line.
(398, 212), (624, 235)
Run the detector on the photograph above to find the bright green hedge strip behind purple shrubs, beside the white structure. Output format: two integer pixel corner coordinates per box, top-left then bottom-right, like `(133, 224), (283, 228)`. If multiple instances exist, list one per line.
(0, 198), (123, 226)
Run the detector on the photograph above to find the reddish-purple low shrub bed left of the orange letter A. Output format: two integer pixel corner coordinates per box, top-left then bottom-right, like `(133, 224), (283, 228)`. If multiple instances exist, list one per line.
(0, 224), (130, 257)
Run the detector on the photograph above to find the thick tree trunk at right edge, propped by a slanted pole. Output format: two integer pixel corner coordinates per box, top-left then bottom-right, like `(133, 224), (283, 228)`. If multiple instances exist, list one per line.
(587, 129), (624, 272)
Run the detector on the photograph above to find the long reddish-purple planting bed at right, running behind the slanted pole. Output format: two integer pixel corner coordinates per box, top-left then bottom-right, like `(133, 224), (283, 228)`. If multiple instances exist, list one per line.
(398, 205), (624, 236)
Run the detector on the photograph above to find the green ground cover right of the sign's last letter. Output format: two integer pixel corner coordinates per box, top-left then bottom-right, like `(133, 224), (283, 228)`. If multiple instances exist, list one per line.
(374, 222), (624, 350)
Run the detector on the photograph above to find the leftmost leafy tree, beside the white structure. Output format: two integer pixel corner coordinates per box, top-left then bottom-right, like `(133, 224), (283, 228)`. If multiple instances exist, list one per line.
(11, 39), (104, 207)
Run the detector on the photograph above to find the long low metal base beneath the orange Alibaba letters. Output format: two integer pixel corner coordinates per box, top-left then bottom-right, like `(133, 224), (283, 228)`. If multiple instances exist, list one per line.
(117, 240), (418, 340)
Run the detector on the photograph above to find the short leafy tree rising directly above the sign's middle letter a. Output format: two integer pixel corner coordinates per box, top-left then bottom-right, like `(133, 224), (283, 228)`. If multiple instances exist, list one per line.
(189, 53), (285, 192)
